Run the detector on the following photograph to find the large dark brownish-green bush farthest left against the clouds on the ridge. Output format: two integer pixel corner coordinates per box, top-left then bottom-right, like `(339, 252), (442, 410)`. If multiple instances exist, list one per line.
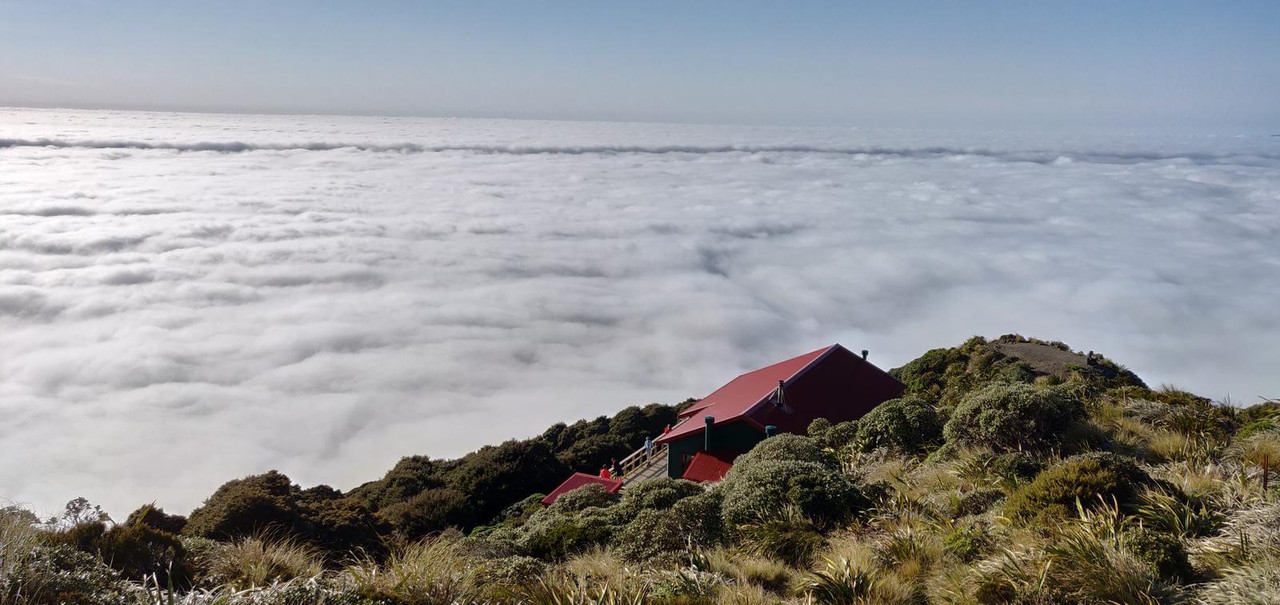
(183, 471), (302, 540)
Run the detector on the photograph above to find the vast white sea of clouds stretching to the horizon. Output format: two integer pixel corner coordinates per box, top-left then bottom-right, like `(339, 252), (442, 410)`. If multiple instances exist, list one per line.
(0, 109), (1280, 517)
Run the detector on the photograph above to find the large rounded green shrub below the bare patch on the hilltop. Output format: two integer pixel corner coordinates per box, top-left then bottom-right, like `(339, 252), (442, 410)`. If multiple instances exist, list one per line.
(943, 384), (1084, 452)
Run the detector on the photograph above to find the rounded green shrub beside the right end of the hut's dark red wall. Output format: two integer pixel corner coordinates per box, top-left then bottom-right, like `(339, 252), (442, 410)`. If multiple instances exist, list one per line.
(854, 395), (942, 454)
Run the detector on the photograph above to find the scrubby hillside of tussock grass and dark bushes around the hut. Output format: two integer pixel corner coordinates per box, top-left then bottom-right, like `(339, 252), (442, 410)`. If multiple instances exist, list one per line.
(0, 336), (1280, 605)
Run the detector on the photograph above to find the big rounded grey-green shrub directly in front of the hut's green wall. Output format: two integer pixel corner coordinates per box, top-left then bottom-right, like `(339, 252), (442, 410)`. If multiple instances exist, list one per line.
(719, 435), (869, 527)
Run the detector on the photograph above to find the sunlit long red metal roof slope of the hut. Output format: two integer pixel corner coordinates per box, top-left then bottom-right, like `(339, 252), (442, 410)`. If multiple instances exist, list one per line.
(655, 344), (840, 443)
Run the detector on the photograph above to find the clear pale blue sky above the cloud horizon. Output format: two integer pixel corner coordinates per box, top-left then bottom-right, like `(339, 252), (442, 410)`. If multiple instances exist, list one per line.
(0, 0), (1280, 128)
